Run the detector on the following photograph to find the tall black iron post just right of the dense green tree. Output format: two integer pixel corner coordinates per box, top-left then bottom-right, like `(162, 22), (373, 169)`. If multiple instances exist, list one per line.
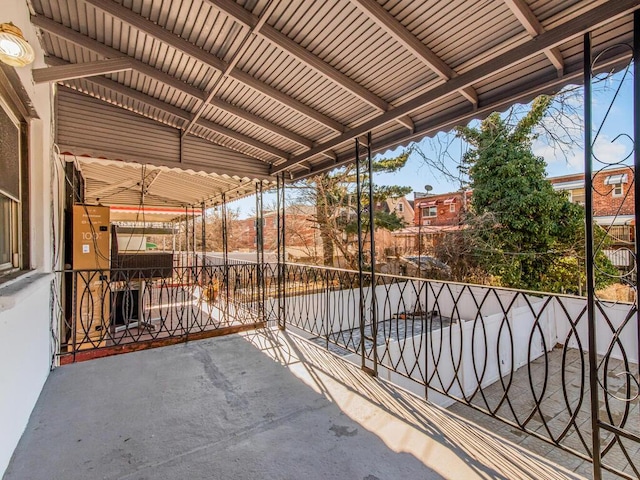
(583, 32), (602, 480)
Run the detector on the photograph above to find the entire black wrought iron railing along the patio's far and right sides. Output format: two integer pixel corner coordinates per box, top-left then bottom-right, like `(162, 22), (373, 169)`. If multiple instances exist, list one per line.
(52, 262), (640, 478)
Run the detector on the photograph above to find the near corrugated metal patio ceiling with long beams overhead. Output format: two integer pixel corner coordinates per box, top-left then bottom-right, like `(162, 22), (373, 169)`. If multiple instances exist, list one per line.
(31, 0), (640, 189)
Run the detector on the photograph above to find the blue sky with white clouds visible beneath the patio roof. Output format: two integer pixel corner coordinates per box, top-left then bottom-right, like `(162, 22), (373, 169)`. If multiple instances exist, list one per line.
(230, 67), (633, 218)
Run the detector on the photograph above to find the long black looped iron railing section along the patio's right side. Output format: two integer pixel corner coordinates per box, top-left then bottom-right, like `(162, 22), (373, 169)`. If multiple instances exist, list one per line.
(284, 265), (640, 478)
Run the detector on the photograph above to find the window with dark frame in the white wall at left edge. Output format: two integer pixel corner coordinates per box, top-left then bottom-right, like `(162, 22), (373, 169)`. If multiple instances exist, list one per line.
(0, 98), (23, 275)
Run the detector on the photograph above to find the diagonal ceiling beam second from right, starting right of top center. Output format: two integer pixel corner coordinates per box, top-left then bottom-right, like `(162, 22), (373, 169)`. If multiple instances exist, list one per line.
(351, 0), (478, 107)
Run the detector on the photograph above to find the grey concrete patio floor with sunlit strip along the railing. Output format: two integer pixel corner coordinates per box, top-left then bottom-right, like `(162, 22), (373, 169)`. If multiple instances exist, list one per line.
(4, 330), (582, 480)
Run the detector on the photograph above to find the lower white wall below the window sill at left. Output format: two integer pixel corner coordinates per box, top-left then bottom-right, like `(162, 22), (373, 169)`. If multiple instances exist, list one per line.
(0, 275), (52, 477)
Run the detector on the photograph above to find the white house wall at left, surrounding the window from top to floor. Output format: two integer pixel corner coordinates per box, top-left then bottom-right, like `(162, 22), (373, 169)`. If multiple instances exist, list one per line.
(0, 0), (61, 477)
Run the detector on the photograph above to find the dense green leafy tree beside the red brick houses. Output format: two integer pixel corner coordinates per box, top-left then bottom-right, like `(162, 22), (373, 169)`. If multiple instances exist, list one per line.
(457, 96), (615, 291)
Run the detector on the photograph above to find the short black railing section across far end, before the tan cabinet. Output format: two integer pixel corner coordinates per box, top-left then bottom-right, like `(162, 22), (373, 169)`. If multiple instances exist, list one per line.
(57, 262), (273, 362)
